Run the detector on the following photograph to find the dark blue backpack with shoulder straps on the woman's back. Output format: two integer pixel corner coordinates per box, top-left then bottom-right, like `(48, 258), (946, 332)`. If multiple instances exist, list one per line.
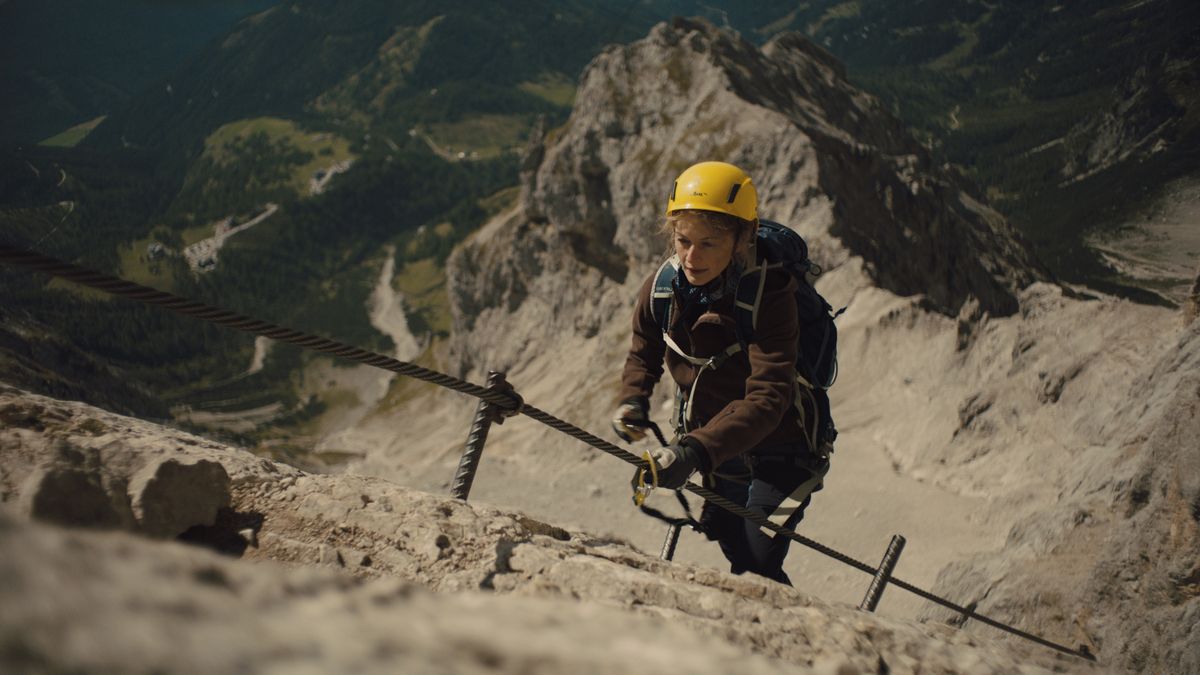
(650, 220), (846, 455)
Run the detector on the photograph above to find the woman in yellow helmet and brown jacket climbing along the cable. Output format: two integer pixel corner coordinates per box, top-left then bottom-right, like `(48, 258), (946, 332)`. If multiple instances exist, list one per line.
(613, 162), (829, 585)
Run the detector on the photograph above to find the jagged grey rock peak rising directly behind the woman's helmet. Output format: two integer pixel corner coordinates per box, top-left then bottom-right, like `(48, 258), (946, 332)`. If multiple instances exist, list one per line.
(448, 19), (1045, 371)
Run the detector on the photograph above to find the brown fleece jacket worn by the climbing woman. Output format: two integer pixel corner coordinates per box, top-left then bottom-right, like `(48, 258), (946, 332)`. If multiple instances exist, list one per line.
(620, 265), (805, 467)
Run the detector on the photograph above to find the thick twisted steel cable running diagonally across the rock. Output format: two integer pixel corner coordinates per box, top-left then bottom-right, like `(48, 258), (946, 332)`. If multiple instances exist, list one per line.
(0, 243), (1096, 661)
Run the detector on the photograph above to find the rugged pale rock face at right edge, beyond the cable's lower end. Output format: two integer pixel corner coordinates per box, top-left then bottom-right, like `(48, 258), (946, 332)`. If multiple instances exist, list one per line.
(926, 321), (1200, 673)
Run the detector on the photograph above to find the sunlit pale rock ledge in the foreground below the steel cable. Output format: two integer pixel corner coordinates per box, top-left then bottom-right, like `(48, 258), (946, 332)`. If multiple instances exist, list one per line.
(0, 388), (1094, 673)
